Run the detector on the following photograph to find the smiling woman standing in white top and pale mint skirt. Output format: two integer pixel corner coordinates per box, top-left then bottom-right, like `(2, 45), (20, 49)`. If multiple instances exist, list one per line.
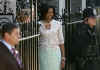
(39, 5), (65, 70)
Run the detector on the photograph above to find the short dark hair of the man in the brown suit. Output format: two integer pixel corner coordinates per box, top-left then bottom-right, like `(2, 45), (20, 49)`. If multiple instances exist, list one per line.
(1, 23), (19, 37)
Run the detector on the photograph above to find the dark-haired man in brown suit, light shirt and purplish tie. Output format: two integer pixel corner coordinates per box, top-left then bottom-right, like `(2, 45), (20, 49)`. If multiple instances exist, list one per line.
(0, 23), (23, 70)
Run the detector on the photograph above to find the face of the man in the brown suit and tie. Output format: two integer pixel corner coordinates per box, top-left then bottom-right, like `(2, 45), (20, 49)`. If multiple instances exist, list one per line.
(8, 28), (20, 46)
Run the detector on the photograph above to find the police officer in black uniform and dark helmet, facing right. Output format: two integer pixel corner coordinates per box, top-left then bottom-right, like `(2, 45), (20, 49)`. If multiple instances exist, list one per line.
(70, 8), (99, 70)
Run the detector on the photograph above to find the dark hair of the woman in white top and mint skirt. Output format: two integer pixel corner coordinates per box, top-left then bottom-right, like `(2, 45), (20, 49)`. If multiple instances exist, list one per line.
(40, 4), (55, 20)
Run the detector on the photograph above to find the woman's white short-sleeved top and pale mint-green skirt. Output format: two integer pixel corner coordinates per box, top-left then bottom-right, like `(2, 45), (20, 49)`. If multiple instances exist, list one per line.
(39, 20), (64, 70)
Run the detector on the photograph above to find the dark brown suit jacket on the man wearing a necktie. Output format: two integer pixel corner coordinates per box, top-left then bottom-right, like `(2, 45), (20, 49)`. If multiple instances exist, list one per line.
(0, 42), (23, 70)
